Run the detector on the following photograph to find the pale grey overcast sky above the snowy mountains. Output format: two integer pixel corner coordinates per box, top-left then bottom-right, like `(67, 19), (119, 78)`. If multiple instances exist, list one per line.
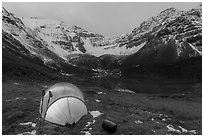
(2, 2), (199, 37)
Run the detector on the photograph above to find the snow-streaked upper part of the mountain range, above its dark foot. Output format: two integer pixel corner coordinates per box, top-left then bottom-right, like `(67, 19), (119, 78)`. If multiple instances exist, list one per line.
(2, 5), (202, 76)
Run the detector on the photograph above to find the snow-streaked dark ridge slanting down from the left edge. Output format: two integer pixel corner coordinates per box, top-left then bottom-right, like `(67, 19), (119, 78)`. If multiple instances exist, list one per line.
(2, 8), (65, 64)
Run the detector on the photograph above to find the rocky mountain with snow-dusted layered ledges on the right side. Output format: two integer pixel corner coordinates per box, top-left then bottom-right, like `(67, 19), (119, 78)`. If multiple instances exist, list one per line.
(119, 5), (202, 65)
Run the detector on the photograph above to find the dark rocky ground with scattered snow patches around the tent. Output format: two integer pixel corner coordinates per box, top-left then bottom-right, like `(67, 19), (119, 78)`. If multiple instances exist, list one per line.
(2, 76), (202, 135)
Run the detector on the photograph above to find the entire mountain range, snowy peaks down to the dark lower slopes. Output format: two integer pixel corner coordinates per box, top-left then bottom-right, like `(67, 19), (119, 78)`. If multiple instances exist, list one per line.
(2, 5), (202, 78)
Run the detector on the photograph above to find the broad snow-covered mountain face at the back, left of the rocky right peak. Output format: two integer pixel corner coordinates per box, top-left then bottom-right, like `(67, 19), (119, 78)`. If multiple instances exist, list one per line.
(2, 8), (156, 60)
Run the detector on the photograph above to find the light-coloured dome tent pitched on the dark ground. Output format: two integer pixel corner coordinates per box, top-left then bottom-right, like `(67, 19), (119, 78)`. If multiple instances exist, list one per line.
(39, 82), (87, 126)
